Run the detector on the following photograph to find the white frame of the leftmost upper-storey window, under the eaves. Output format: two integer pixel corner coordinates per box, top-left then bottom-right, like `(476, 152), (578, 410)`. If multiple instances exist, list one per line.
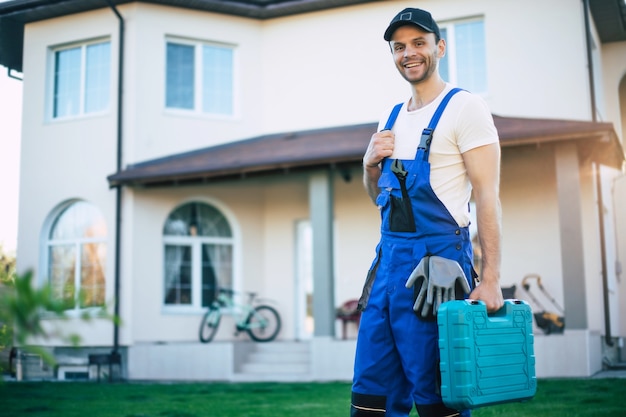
(46, 37), (113, 121)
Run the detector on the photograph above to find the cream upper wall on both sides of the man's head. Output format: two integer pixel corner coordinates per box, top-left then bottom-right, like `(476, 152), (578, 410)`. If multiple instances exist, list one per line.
(256, 0), (590, 131)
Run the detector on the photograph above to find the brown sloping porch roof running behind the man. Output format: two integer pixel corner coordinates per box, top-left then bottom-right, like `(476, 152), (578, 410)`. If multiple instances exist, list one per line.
(108, 116), (624, 186)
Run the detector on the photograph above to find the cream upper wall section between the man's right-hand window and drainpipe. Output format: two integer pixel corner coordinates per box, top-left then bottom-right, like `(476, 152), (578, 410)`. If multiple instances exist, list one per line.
(482, 0), (591, 120)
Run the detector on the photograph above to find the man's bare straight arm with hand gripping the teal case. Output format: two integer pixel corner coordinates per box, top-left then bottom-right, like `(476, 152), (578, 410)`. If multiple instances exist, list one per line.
(463, 143), (503, 311)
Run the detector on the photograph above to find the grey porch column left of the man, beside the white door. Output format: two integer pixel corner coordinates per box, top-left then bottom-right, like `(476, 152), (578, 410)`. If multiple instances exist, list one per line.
(309, 170), (335, 337)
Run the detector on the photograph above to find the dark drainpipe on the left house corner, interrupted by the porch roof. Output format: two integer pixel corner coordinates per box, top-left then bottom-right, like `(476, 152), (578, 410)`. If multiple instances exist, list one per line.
(106, 0), (124, 356)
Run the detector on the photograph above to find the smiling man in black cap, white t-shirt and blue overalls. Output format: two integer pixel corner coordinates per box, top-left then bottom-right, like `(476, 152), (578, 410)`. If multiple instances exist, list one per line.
(351, 8), (503, 417)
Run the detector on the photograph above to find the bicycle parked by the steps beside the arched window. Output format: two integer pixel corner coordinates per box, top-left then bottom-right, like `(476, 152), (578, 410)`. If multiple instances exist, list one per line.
(199, 289), (281, 343)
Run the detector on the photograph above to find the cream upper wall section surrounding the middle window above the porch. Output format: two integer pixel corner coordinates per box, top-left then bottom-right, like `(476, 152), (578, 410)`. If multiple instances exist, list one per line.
(120, 3), (264, 162)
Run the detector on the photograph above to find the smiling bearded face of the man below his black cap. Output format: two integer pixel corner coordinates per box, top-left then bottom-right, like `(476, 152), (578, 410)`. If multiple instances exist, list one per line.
(389, 25), (445, 84)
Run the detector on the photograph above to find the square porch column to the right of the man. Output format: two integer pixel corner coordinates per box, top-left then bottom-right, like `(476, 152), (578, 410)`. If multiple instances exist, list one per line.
(555, 143), (587, 329)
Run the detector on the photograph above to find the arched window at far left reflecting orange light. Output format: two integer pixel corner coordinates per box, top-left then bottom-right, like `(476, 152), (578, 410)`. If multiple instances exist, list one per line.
(47, 201), (107, 310)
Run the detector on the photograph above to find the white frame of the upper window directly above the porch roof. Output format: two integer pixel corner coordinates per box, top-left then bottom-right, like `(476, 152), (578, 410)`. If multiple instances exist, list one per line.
(163, 36), (239, 120)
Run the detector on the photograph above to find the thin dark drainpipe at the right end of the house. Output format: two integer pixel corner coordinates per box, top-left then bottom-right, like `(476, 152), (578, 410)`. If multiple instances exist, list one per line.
(583, 0), (613, 346)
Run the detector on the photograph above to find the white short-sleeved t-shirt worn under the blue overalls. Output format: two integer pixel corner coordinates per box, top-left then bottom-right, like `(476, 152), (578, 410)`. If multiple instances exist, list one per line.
(378, 84), (499, 227)
